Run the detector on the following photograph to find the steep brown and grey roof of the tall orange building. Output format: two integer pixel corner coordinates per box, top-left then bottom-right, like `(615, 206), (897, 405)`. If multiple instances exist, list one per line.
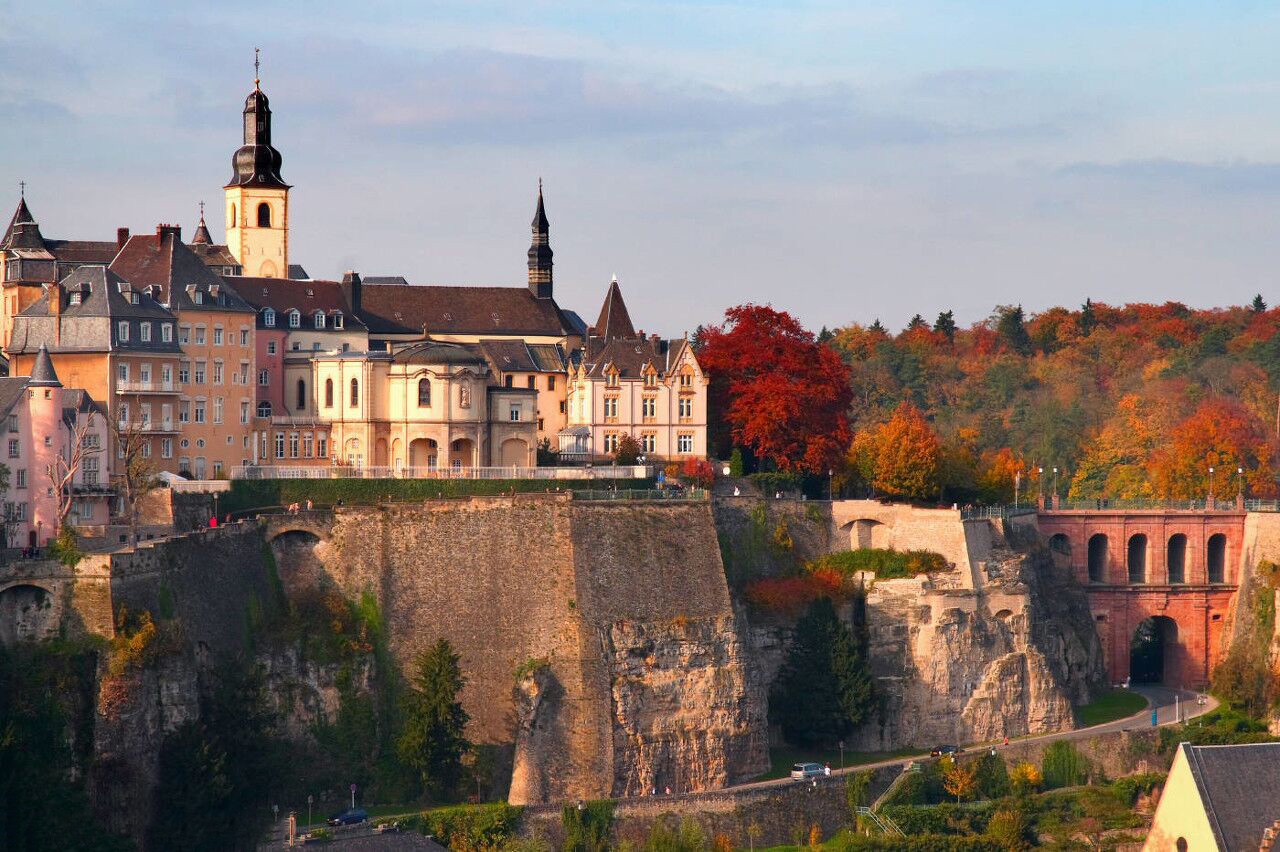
(110, 230), (255, 313)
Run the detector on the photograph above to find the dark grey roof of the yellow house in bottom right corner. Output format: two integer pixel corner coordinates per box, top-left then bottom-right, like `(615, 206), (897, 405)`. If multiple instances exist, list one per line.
(1179, 742), (1280, 852)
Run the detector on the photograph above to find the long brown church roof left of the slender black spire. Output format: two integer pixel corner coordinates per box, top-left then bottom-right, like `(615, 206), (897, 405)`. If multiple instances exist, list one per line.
(360, 284), (572, 336)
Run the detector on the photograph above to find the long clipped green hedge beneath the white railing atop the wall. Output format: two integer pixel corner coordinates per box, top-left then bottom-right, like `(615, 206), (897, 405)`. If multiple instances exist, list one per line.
(218, 478), (654, 513)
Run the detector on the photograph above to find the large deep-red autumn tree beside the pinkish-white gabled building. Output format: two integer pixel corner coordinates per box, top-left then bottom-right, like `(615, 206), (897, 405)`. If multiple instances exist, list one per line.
(698, 304), (852, 472)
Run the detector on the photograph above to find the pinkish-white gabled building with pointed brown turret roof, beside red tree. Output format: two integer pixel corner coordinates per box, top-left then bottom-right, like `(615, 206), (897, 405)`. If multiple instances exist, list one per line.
(559, 279), (708, 462)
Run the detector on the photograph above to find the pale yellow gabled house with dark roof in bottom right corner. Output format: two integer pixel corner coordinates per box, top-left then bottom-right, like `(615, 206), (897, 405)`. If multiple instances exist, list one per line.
(1142, 742), (1280, 852)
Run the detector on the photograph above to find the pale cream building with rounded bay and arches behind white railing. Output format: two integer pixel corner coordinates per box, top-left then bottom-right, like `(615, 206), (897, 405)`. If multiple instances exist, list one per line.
(311, 342), (538, 472)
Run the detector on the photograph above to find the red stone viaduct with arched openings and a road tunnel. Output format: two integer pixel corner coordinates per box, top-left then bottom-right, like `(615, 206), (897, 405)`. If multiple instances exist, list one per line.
(1038, 508), (1245, 688)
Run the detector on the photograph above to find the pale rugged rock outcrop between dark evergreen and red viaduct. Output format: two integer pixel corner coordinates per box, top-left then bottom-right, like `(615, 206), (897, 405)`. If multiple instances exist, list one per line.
(855, 534), (1103, 750)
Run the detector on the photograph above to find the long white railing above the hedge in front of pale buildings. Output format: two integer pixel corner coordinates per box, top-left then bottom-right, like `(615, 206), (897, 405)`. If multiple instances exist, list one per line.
(230, 464), (653, 480)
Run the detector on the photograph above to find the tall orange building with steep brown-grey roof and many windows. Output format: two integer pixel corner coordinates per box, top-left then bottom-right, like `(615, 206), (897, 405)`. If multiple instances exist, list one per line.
(110, 225), (256, 480)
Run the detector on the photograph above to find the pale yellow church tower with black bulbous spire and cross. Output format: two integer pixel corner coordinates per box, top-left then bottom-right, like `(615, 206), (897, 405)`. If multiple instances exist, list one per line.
(225, 55), (289, 278)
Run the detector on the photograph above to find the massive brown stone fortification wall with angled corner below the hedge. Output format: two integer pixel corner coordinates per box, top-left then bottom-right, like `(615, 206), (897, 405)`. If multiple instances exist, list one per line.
(268, 495), (765, 802)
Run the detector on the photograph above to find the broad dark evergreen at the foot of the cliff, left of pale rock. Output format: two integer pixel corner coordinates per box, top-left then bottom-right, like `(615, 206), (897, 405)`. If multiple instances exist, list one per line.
(769, 597), (873, 746)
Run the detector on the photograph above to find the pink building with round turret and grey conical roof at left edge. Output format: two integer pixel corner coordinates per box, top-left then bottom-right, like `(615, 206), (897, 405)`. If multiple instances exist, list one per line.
(0, 347), (111, 548)
